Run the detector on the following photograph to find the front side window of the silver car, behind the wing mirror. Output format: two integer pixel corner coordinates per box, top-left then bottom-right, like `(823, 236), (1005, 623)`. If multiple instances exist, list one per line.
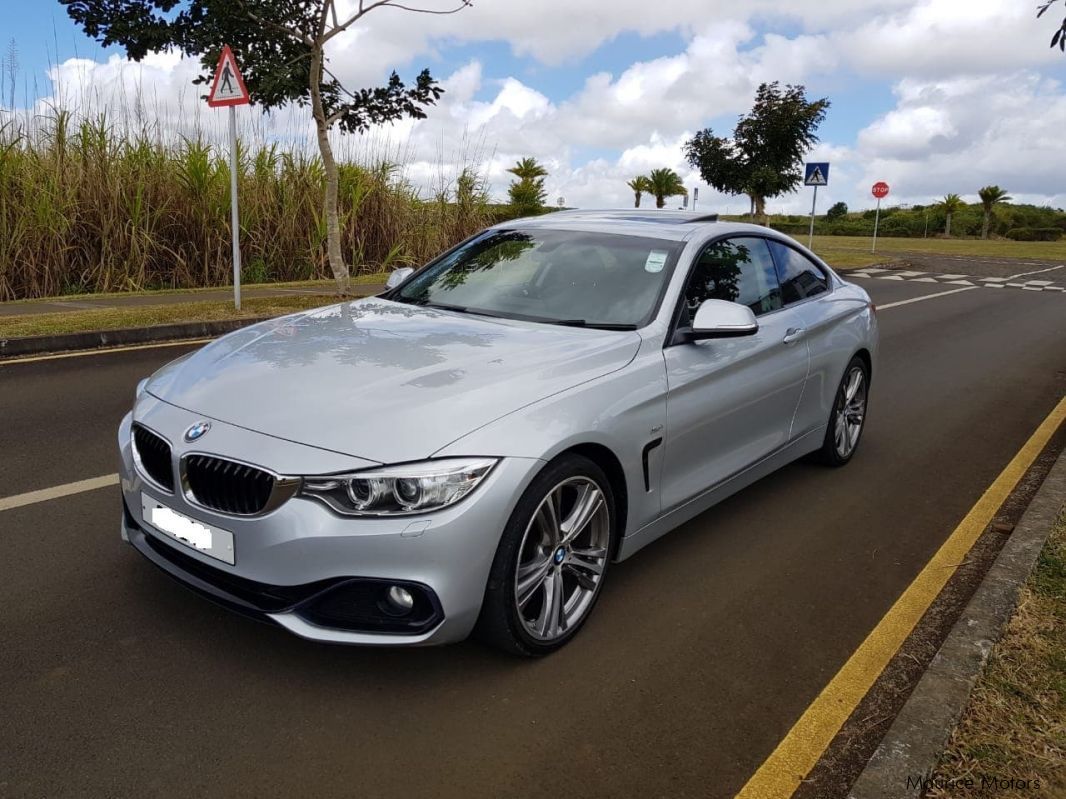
(684, 238), (781, 320)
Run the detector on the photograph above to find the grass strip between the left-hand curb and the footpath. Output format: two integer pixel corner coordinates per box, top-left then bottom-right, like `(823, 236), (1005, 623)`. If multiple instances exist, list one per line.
(0, 295), (338, 339)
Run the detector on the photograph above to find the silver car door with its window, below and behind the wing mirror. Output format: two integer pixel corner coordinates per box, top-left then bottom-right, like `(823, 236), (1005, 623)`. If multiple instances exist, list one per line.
(661, 237), (809, 510)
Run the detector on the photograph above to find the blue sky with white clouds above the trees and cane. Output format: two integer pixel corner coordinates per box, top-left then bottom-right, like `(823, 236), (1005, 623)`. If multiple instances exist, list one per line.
(0, 0), (1066, 213)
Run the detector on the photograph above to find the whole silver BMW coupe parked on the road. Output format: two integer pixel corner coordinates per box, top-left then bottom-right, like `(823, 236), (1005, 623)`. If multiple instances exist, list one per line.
(118, 211), (877, 656)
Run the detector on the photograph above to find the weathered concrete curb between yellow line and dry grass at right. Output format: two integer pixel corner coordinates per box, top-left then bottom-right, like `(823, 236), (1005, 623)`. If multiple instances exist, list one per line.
(849, 451), (1066, 799)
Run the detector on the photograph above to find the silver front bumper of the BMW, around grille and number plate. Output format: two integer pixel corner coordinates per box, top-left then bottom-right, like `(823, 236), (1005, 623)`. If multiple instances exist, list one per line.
(118, 397), (543, 646)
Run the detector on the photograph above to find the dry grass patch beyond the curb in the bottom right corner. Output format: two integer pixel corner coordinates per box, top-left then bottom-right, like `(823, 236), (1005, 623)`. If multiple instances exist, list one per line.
(930, 515), (1066, 799)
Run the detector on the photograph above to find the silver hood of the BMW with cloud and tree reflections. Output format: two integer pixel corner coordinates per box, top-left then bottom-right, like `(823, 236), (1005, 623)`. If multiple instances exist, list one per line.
(146, 298), (641, 462)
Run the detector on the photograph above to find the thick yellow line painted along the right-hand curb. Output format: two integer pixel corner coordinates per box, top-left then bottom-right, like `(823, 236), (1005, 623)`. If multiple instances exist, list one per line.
(737, 397), (1066, 799)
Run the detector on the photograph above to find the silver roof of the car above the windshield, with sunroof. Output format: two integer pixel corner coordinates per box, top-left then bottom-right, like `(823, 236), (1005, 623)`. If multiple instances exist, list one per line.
(492, 208), (788, 242)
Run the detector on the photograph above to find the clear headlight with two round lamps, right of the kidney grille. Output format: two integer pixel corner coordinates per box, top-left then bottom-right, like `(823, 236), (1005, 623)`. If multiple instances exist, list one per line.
(300, 458), (496, 516)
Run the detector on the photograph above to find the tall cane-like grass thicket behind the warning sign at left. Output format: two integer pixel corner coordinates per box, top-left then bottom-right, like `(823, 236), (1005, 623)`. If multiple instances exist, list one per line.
(0, 111), (494, 300)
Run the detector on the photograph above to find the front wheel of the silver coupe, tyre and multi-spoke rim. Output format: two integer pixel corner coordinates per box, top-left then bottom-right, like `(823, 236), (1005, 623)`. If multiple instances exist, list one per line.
(474, 454), (617, 657)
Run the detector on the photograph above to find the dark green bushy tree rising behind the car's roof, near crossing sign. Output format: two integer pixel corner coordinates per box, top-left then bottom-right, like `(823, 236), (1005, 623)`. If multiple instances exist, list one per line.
(684, 81), (829, 222)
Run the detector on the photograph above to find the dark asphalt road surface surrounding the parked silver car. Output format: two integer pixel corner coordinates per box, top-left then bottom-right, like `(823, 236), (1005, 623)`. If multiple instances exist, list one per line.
(0, 280), (1066, 797)
